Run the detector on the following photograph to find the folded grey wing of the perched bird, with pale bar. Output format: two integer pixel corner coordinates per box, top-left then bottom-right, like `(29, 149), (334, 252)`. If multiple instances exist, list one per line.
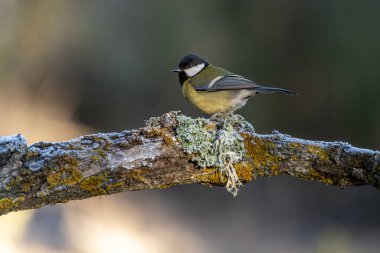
(195, 74), (261, 91)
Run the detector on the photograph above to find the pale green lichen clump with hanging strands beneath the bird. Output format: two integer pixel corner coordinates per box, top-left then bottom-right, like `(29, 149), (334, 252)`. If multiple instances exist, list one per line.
(176, 115), (253, 196)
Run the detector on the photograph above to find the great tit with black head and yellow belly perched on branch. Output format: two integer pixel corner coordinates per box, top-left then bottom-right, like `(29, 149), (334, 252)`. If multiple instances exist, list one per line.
(172, 53), (296, 118)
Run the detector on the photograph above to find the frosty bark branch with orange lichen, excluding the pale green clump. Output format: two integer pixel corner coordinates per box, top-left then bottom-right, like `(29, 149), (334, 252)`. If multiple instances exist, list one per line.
(0, 113), (380, 215)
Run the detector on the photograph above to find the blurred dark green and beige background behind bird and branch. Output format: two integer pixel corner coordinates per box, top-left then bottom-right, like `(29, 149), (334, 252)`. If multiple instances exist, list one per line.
(0, 0), (380, 253)
